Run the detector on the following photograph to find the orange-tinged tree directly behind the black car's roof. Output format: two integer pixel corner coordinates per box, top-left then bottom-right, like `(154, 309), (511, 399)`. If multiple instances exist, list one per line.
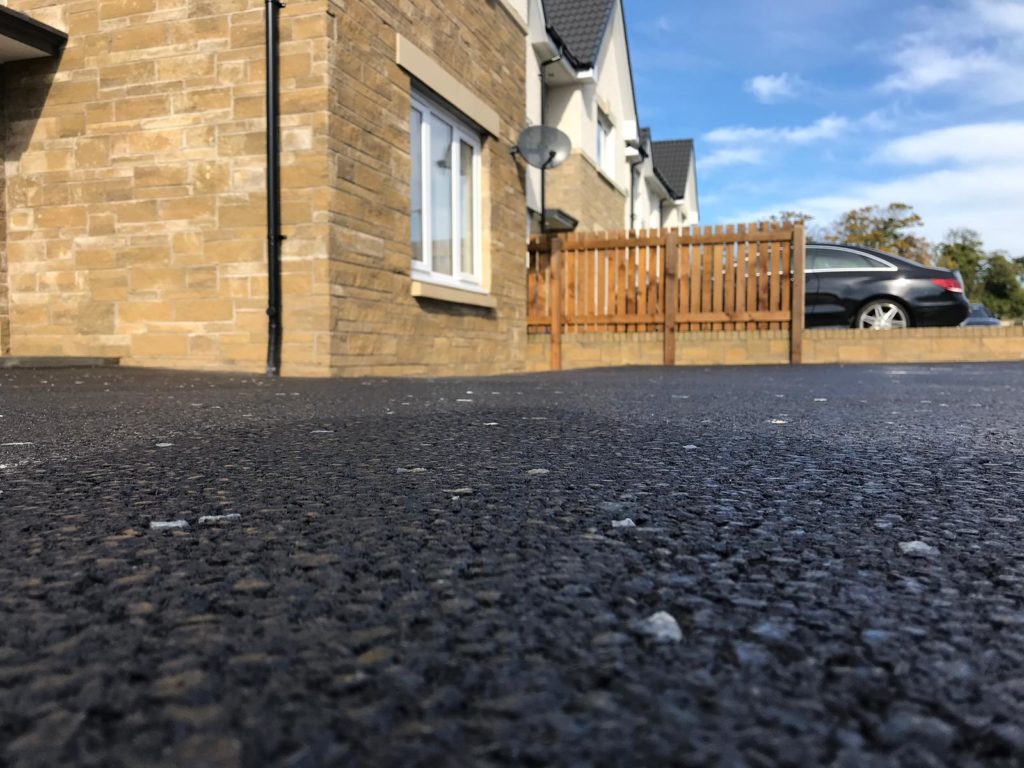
(823, 203), (932, 264)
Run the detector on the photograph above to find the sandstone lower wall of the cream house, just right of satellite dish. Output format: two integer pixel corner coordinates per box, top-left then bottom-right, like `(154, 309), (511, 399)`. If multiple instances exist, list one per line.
(545, 152), (628, 231)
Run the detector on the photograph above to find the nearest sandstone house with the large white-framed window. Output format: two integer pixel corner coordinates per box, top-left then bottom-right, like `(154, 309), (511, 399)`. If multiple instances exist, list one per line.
(0, 0), (536, 376)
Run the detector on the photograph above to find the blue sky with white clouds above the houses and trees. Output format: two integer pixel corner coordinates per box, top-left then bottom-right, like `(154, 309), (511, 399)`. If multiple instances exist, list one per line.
(625, 0), (1024, 256)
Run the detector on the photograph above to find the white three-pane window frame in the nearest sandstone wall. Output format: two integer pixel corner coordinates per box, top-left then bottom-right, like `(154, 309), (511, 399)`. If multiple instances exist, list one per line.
(410, 92), (484, 293)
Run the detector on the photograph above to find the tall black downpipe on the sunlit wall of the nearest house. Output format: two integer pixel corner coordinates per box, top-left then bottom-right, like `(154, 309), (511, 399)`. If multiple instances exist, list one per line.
(264, 0), (285, 376)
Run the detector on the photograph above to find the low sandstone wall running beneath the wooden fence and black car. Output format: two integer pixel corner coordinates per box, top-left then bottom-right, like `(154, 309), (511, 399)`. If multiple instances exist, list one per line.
(526, 326), (1024, 371)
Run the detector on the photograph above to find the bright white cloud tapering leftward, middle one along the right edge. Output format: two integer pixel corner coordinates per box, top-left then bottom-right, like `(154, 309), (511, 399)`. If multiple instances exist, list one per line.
(876, 122), (1024, 165)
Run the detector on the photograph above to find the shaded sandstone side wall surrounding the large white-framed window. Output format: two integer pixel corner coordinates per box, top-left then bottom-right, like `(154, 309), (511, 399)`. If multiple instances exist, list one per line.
(319, 0), (526, 375)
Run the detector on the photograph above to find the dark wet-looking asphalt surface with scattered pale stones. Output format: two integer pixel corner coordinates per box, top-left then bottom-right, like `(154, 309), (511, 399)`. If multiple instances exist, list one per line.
(0, 365), (1024, 768)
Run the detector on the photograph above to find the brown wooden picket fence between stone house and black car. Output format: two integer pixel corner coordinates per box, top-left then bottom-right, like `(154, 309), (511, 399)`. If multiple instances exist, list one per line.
(526, 223), (804, 370)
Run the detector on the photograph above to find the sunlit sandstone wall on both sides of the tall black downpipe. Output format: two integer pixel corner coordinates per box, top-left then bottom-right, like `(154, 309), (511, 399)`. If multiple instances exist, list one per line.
(0, 0), (330, 374)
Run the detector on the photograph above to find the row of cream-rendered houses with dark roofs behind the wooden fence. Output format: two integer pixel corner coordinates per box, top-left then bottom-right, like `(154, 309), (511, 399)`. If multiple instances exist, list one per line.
(526, 0), (697, 231)
